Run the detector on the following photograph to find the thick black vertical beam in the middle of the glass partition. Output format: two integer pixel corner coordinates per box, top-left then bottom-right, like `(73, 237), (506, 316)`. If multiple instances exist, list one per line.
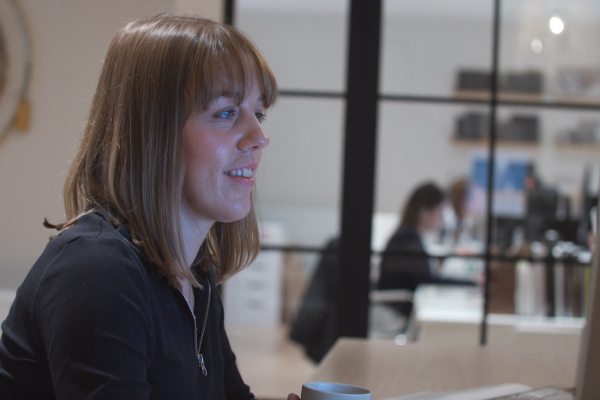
(337, 0), (381, 337)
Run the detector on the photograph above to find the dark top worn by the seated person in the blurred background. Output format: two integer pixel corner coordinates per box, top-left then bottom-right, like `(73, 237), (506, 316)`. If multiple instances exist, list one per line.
(377, 229), (474, 316)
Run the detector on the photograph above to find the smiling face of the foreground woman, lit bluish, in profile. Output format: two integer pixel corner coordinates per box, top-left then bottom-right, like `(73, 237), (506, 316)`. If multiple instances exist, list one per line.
(181, 80), (269, 225)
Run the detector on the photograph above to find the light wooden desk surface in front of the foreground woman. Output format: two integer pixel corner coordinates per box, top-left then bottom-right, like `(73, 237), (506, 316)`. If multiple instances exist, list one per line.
(311, 335), (579, 400)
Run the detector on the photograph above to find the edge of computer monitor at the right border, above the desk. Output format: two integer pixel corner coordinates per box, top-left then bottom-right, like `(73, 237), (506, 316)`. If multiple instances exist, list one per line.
(575, 195), (600, 400)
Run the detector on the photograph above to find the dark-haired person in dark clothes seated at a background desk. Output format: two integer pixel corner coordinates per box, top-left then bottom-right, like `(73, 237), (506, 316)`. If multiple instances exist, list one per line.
(377, 183), (474, 317)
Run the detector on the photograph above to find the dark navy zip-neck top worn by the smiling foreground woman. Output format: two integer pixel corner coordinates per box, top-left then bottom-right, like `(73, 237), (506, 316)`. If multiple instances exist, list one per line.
(0, 213), (254, 400)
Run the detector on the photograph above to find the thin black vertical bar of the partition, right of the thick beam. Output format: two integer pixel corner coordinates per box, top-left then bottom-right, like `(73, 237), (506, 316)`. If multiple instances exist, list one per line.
(480, 0), (500, 346)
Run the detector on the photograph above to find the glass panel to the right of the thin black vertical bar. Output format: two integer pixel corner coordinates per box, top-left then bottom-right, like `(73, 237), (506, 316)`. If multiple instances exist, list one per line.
(482, 0), (600, 329)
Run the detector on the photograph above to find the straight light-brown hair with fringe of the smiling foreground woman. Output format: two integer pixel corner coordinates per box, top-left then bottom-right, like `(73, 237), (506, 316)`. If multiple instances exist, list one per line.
(53, 14), (277, 286)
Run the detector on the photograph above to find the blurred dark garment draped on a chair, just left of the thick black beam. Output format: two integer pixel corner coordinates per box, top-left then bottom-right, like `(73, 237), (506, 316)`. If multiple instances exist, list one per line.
(290, 239), (340, 363)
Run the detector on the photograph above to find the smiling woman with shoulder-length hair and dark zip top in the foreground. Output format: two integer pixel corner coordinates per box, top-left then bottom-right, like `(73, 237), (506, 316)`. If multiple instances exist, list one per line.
(0, 15), (290, 400)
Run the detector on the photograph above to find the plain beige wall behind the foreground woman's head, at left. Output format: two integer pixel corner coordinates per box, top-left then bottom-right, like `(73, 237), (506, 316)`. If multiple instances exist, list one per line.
(0, 0), (222, 287)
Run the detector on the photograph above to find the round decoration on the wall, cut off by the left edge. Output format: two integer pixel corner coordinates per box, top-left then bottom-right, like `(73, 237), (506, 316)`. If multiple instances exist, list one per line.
(0, 0), (29, 136)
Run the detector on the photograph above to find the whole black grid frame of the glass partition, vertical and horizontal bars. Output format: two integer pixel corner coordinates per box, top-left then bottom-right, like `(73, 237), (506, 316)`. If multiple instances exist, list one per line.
(224, 0), (600, 346)
